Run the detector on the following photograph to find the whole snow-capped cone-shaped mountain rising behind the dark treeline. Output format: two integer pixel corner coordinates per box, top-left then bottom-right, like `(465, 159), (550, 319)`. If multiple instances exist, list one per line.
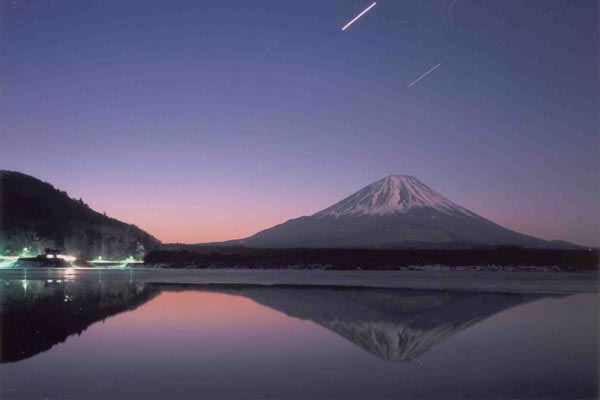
(236, 175), (576, 248)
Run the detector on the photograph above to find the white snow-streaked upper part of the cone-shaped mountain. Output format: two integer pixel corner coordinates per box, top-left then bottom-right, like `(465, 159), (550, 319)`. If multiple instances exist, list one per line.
(314, 175), (471, 217)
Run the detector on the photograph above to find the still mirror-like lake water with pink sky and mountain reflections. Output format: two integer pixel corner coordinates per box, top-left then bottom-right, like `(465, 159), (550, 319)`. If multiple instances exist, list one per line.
(0, 276), (599, 399)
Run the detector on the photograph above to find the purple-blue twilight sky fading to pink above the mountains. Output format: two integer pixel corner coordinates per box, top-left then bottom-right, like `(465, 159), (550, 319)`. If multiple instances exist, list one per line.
(0, 0), (600, 245)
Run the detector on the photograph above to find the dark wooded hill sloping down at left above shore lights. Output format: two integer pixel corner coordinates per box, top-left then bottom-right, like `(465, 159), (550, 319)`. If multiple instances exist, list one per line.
(0, 171), (159, 259)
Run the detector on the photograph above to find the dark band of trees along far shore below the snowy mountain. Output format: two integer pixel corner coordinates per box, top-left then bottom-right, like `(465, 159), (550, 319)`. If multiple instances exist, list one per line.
(144, 246), (600, 272)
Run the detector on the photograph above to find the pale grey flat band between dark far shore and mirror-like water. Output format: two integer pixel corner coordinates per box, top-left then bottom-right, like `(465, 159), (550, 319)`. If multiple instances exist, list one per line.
(0, 268), (600, 294)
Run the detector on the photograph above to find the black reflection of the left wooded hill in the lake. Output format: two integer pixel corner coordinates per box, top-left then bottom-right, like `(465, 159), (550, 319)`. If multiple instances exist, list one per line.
(0, 281), (160, 363)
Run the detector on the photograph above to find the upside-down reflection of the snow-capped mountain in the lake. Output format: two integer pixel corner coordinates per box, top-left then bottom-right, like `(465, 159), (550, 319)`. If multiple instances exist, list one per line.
(189, 287), (548, 361)
